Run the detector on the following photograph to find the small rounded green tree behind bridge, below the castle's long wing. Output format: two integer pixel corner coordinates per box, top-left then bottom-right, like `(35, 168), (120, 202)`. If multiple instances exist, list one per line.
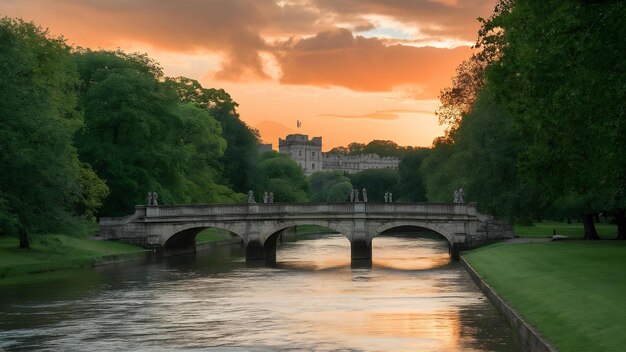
(349, 169), (400, 202)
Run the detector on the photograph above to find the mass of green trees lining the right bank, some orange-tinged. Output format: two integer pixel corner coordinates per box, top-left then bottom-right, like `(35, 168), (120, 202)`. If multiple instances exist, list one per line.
(414, 0), (626, 239)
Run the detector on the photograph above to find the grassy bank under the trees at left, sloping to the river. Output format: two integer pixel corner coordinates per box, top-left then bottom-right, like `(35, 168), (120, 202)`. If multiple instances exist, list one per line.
(0, 235), (144, 278)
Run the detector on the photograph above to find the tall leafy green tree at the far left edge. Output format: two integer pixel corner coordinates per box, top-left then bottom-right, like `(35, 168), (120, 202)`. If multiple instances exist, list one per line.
(0, 18), (107, 248)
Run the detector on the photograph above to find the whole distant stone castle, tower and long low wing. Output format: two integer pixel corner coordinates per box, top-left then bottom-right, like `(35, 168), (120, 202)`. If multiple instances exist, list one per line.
(278, 134), (400, 176)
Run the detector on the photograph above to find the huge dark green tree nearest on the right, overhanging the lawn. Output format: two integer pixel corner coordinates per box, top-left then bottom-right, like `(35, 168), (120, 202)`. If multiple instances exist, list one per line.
(479, 0), (626, 239)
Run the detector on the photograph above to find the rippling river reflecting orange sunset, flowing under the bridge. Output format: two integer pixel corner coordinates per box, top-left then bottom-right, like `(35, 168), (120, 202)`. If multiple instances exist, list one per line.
(0, 235), (518, 351)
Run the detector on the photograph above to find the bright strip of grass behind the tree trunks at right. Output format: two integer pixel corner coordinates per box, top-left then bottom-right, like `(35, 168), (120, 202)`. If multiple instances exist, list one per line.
(515, 222), (617, 239)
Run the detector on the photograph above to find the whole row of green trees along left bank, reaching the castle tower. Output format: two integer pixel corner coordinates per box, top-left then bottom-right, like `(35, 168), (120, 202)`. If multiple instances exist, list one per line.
(0, 18), (300, 247)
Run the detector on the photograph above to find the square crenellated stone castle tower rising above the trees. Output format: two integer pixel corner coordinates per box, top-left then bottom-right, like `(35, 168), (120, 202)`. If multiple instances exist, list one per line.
(278, 134), (322, 176)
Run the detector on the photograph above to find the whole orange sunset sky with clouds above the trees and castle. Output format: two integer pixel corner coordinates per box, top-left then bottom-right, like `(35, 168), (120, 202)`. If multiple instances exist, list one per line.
(0, 0), (495, 150)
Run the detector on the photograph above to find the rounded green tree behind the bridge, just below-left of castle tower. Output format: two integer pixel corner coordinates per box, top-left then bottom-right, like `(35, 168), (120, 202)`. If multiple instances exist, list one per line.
(256, 151), (310, 202)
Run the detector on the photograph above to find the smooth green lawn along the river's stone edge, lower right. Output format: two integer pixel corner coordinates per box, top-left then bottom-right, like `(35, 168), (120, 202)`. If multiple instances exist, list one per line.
(463, 241), (626, 351)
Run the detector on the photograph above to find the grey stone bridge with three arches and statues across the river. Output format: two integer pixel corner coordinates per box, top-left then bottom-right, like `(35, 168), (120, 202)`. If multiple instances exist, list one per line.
(100, 203), (513, 263)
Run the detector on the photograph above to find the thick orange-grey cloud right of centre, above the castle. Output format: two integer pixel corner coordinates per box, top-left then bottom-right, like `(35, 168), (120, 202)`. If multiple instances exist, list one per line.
(277, 29), (470, 98)
